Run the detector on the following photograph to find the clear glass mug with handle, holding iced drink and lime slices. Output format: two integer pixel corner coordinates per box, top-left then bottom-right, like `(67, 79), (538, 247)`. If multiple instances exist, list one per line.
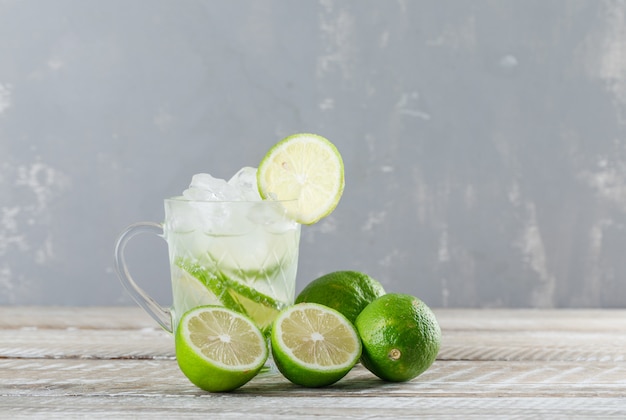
(115, 197), (300, 334)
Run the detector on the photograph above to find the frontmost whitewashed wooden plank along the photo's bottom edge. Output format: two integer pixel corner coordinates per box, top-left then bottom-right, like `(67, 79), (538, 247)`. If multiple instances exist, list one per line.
(0, 395), (626, 420)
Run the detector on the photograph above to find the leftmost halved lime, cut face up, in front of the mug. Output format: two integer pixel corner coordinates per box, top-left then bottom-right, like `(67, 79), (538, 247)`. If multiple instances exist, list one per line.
(175, 306), (269, 392)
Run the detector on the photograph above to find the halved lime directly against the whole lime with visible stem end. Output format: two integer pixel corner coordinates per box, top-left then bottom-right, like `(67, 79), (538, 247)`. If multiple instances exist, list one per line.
(271, 303), (361, 387)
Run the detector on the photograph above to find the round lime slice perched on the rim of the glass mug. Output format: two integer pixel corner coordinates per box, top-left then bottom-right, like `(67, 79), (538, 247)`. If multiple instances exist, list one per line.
(257, 134), (345, 225)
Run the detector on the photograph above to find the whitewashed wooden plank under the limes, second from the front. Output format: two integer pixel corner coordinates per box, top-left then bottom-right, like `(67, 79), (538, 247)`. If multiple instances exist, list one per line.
(0, 359), (626, 403)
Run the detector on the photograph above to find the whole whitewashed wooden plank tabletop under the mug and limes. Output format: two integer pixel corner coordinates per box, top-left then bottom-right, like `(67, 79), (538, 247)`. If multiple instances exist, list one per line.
(0, 306), (626, 419)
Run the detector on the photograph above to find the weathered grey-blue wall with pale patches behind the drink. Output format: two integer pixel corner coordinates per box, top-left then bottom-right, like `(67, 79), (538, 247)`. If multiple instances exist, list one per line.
(0, 0), (626, 307)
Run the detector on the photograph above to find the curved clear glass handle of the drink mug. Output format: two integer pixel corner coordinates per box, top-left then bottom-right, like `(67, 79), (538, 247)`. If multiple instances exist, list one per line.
(115, 222), (173, 334)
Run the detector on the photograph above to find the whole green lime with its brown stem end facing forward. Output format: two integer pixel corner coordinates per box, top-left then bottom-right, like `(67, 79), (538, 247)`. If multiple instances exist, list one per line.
(355, 293), (441, 382)
